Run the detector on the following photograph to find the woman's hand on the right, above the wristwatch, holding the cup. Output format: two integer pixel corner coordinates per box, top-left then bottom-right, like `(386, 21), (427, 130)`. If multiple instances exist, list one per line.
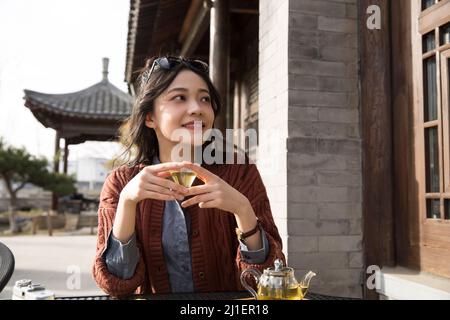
(181, 162), (251, 215)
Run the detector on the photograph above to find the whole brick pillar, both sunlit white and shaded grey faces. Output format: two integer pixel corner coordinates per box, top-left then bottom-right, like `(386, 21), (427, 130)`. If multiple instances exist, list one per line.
(259, 0), (363, 297)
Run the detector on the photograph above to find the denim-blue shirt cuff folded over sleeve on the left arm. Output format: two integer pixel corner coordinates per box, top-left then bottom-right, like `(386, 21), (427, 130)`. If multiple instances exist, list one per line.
(104, 232), (140, 279)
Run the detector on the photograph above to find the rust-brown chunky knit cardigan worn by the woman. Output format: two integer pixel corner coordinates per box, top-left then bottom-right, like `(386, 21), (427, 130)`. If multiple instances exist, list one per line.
(93, 159), (285, 296)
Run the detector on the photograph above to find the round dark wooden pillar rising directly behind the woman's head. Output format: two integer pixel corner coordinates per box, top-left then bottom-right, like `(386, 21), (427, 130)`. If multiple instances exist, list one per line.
(209, 0), (230, 137)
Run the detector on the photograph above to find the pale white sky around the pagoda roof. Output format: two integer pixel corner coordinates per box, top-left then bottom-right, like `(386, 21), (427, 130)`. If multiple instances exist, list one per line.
(0, 0), (130, 161)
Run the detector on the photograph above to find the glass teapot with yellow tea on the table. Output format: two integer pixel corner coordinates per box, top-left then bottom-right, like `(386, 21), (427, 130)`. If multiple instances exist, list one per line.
(241, 259), (316, 300)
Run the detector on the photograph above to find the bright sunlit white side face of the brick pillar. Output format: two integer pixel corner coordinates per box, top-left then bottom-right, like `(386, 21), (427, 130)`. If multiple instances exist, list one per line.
(257, 0), (289, 250)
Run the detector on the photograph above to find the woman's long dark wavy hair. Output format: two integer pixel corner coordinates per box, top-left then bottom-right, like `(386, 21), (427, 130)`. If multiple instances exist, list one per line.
(114, 57), (221, 166)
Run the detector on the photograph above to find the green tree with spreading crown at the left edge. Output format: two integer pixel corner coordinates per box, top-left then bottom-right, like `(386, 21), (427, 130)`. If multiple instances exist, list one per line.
(0, 137), (75, 232)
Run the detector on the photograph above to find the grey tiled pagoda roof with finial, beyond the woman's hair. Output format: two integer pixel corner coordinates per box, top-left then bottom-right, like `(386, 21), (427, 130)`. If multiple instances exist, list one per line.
(24, 58), (133, 144)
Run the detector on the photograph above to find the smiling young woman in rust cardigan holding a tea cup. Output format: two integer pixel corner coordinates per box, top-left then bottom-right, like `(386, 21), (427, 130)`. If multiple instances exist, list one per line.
(93, 57), (284, 296)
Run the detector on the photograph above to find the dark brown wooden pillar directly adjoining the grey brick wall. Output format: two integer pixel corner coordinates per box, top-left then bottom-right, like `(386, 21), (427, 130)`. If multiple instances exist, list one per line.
(358, 0), (395, 299)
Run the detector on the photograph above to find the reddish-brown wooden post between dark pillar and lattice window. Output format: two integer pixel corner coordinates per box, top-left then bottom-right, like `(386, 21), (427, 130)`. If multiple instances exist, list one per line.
(391, 1), (422, 269)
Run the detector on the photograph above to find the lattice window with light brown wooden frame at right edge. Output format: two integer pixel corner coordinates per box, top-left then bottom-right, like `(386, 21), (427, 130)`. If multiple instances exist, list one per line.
(419, 0), (450, 277)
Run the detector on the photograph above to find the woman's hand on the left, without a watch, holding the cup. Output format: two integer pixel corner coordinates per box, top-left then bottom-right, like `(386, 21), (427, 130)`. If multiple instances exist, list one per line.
(120, 162), (188, 204)
